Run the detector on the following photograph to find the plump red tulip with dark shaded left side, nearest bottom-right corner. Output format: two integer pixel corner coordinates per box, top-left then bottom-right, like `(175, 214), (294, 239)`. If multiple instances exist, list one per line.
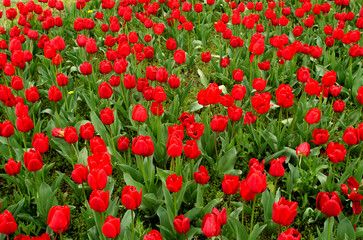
(316, 191), (343, 217)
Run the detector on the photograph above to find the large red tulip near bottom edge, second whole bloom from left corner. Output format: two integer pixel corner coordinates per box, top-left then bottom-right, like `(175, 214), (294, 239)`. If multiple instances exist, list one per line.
(47, 205), (71, 234)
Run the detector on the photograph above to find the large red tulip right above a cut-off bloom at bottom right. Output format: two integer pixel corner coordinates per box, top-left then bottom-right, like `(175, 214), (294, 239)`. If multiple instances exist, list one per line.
(272, 198), (297, 226)
